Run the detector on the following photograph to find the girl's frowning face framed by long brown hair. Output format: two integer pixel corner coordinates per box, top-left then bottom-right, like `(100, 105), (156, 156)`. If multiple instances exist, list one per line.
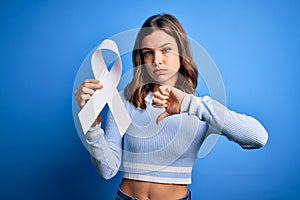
(141, 30), (180, 86)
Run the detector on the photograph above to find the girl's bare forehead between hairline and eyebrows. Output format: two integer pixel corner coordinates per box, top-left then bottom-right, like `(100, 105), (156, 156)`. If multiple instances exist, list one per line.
(141, 30), (177, 49)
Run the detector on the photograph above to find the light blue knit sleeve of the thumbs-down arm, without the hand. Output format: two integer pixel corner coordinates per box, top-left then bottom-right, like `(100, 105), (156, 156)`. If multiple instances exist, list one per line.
(181, 94), (268, 149)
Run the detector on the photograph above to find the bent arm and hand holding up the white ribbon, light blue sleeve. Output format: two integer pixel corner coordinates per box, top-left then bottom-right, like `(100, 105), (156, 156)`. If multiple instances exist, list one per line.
(74, 79), (122, 179)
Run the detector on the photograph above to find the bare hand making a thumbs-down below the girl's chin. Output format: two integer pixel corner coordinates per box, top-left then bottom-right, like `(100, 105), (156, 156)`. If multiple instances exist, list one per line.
(152, 86), (185, 124)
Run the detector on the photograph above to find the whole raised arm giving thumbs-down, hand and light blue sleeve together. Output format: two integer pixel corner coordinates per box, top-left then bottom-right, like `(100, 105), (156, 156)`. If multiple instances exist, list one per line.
(153, 87), (268, 149)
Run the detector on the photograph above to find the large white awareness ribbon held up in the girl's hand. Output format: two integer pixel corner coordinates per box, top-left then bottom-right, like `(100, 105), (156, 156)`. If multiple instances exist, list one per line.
(78, 39), (131, 137)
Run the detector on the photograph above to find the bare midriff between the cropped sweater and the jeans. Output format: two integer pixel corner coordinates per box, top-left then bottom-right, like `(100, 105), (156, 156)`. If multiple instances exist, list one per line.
(120, 178), (188, 200)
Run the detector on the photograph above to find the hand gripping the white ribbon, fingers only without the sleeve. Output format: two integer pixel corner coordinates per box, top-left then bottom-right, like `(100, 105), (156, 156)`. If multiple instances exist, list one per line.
(74, 79), (103, 108)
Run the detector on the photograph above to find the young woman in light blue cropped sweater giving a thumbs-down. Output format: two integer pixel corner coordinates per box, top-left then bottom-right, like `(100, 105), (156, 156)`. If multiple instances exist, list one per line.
(75, 14), (268, 200)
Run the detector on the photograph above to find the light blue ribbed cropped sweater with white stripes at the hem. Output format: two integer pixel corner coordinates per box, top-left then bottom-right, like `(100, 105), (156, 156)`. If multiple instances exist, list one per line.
(86, 93), (268, 184)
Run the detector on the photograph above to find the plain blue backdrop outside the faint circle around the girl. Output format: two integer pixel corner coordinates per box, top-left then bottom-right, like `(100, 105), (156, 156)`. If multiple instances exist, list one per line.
(0, 0), (300, 200)
